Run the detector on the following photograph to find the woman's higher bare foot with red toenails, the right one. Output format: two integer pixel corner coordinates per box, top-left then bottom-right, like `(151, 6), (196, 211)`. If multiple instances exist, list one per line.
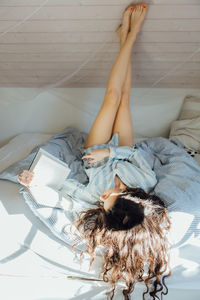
(130, 4), (147, 35)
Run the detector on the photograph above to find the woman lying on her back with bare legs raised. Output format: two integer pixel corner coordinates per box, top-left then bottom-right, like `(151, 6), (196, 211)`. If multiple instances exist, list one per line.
(19, 4), (170, 299)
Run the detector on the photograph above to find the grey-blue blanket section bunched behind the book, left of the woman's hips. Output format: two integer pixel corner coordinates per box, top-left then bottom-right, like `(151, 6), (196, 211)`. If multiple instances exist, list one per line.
(0, 127), (87, 184)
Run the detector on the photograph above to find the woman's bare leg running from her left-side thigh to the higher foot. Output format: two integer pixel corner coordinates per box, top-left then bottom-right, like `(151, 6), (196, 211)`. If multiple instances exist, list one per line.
(85, 5), (146, 148)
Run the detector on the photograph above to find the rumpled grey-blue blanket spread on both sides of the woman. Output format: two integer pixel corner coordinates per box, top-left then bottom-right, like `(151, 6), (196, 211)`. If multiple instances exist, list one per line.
(0, 127), (200, 248)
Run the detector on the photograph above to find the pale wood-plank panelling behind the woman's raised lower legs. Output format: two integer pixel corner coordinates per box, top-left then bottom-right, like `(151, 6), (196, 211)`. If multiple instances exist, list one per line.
(0, 0), (200, 88)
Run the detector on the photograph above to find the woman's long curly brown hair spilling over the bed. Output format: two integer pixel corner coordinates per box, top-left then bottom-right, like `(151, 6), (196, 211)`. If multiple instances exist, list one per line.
(74, 188), (171, 300)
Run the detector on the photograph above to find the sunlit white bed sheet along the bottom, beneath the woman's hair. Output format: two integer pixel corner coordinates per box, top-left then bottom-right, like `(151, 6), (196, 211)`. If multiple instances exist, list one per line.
(0, 181), (200, 300)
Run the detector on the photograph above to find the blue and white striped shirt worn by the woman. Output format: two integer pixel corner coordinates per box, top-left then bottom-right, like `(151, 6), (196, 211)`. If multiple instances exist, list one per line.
(63, 134), (157, 204)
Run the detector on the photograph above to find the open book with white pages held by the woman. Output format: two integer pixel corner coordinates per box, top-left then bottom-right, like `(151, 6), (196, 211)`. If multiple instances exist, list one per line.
(28, 148), (71, 209)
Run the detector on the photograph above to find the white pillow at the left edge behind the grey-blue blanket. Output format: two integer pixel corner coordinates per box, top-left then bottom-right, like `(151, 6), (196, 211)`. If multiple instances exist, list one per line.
(0, 133), (53, 172)
